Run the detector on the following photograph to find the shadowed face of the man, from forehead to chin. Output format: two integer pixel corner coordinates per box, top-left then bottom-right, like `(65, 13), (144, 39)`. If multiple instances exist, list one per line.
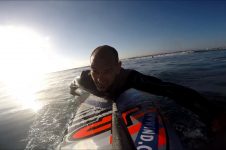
(91, 56), (121, 92)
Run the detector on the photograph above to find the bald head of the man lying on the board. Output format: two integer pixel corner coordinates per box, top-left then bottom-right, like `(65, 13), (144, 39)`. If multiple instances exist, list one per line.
(90, 45), (121, 91)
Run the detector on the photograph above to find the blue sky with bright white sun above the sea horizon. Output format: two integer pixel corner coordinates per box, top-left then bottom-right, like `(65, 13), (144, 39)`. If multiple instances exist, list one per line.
(0, 0), (226, 72)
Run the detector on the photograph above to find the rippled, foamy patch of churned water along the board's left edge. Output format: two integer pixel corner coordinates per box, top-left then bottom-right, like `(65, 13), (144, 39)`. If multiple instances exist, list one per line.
(26, 98), (76, 150)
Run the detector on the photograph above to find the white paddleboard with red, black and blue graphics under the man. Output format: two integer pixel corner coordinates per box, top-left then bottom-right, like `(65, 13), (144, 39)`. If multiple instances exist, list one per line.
(57, 89), (182, 150)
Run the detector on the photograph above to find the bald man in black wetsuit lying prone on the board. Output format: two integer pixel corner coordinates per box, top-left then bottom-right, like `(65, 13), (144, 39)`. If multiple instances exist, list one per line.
(70, 45), (222, 135)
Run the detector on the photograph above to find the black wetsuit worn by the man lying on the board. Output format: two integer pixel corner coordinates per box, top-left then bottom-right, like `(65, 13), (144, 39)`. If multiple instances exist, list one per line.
(71, 68), (221, 123)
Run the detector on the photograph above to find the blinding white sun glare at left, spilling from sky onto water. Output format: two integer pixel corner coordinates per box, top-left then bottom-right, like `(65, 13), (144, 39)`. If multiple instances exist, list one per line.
(0, 26), (52, 111)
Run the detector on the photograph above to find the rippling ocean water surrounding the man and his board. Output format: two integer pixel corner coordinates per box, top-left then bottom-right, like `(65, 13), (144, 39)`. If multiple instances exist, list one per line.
(0, 50), (226, 149)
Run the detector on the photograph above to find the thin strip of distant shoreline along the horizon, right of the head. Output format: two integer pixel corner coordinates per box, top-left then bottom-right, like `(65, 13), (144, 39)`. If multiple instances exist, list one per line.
(120, 48), (226, 61)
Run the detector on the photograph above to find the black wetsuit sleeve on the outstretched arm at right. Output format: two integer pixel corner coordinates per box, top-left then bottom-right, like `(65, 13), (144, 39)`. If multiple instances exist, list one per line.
(128, 71), (218, 123)
